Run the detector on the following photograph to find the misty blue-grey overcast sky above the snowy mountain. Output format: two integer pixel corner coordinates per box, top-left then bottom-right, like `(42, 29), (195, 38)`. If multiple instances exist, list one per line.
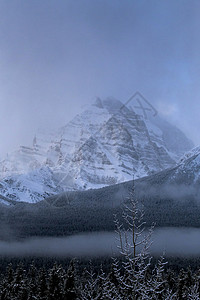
(0, 0), (200, 155)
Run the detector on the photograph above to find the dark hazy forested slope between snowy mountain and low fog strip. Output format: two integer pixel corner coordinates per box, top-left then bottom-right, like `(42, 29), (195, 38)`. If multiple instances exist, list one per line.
(0, 171), (200, 240)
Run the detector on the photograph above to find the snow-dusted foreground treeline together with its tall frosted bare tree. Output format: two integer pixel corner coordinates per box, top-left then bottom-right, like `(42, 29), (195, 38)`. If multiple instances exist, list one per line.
(0, 189), (200, 300)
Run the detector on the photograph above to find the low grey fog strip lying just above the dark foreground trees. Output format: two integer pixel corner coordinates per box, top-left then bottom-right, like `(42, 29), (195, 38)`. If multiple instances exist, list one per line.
(0, 227), (200, 257)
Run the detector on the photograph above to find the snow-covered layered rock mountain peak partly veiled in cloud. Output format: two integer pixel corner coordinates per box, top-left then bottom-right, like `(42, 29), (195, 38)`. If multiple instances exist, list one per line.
(0, 98), (193, 202)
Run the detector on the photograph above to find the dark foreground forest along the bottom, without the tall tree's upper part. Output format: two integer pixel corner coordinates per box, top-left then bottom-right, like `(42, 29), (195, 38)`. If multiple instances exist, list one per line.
(0, 259), (200, 300)
